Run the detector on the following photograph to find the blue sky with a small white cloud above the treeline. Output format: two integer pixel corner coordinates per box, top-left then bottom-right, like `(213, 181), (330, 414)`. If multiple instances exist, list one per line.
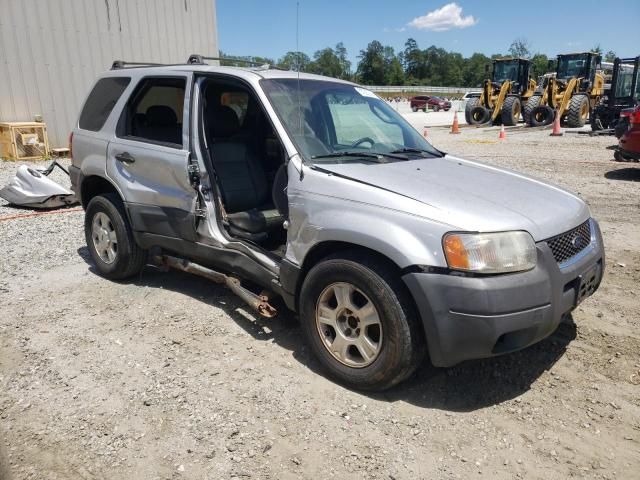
(216, 0), (640, 67)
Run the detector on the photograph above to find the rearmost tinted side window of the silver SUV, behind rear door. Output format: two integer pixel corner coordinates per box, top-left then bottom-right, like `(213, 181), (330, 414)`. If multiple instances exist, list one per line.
(78, 77), (131, 132)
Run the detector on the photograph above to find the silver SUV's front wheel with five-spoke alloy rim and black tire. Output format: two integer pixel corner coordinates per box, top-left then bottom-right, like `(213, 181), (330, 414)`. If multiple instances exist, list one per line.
(300, 251), (425, 391)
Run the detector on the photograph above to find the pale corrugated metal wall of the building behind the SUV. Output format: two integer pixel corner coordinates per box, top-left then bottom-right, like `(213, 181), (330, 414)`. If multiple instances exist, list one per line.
(0, 0), (218, 146)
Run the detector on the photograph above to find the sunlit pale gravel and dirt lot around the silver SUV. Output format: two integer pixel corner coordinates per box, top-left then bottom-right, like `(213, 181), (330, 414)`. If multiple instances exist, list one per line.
(0, 128), (640, 480)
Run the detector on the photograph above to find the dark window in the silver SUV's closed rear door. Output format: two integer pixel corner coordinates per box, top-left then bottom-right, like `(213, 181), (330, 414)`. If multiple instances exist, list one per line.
(119, 77), (187, 146)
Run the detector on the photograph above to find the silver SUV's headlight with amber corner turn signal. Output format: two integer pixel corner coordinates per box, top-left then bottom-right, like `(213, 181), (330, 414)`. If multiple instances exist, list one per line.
(442, 232), (537, 273)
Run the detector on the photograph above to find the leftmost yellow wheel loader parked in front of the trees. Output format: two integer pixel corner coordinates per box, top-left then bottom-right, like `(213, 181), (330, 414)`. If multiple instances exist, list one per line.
(464, 58), (536, 126)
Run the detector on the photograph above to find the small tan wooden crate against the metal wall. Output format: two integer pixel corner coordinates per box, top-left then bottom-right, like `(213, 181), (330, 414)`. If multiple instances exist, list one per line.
(0, 122), (49, 160)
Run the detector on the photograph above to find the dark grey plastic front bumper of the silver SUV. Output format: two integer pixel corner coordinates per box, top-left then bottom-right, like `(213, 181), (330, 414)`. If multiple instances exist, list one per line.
(402, 220), (604, 367)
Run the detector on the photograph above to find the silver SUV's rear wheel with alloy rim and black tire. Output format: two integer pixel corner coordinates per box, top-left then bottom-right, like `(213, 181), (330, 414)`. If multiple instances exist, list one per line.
(84, 193), (147, 280)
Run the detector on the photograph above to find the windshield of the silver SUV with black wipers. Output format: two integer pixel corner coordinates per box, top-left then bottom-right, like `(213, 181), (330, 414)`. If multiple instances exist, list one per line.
(261, 79), (442, 163)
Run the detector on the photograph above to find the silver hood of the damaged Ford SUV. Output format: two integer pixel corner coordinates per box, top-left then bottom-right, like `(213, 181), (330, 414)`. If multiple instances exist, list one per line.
(321, 155), (589, 241)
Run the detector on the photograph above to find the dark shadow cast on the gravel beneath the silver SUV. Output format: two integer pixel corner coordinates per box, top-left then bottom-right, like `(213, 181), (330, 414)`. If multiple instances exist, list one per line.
(77, 247), (576, 412)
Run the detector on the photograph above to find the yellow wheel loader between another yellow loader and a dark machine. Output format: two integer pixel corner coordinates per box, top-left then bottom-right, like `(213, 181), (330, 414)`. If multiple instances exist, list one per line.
(525, 52), (604, 128)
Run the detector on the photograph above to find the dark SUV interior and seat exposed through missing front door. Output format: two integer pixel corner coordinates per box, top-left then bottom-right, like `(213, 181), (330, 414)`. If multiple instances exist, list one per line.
(203, 80), (287, 251)
